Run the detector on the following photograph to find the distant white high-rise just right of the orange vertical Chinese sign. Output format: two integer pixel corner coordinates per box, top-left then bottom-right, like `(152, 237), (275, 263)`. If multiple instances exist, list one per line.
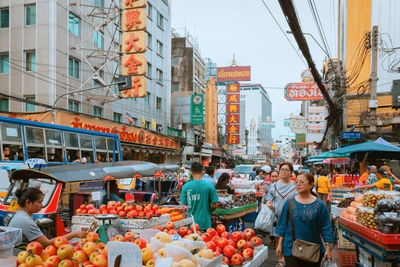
(240, 83), (272, 158)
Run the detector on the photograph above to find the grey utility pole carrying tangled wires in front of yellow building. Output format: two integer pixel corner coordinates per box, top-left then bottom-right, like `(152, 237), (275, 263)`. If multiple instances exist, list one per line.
(369, 26), (378, 133)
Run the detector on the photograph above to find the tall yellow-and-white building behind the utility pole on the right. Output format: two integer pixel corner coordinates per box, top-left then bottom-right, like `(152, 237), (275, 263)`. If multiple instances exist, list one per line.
(337, 0), (400, 140)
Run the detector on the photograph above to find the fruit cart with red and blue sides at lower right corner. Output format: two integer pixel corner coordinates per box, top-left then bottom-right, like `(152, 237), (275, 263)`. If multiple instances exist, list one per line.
(338, 190), (400, 267)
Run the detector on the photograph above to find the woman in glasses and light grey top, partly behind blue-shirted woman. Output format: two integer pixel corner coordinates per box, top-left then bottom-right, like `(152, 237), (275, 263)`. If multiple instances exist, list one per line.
(265, 162), (297, 267)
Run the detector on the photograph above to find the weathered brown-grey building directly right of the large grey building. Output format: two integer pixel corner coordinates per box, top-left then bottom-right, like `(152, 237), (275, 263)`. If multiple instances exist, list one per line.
(171, 30), (208, 161)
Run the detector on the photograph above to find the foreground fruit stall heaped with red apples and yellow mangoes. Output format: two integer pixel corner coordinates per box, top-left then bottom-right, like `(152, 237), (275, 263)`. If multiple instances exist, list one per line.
(13, 222), (268, 267)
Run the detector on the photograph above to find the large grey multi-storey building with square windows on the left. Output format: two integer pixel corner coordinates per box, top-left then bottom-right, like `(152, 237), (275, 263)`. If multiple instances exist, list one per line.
(0, 0), (179, 162)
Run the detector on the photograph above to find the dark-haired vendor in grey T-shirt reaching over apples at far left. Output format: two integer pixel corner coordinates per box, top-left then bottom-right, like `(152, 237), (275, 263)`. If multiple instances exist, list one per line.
(8, 187), (87, 244)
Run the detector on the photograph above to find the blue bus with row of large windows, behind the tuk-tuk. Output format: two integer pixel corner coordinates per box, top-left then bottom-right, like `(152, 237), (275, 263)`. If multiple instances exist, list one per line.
(0, 116), (122, 165)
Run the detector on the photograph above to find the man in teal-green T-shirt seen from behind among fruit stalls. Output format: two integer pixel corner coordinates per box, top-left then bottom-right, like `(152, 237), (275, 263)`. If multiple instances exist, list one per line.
(181, 162), (218, 230)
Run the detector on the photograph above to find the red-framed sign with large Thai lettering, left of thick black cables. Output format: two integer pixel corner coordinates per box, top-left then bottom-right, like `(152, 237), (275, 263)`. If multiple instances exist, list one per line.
(285, 82), (326, 101)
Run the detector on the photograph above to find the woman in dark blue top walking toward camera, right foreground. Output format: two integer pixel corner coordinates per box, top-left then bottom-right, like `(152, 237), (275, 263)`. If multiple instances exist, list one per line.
(275, 173), (335, 267)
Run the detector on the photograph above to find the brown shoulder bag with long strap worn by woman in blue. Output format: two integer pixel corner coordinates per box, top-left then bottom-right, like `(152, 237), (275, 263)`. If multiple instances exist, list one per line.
(289, 197), (321, 263)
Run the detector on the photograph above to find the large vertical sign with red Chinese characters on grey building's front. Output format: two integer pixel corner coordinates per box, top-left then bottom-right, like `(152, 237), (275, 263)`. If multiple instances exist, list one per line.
(121, 0), (147, 98)
